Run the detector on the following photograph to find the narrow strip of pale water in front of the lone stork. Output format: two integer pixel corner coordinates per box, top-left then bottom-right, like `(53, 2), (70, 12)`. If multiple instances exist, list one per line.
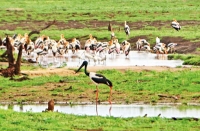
(0, 104), (200, 118)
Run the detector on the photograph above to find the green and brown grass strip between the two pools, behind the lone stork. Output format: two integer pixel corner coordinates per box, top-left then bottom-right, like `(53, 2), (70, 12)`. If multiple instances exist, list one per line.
(0, 69), (200, 105)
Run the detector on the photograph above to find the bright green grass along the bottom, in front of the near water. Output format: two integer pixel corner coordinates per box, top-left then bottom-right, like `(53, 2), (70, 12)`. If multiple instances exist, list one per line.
(0, 110), (200, 131)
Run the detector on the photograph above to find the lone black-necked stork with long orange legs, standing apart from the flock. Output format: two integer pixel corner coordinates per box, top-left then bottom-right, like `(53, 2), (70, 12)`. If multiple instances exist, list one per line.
(76, 61), (113, 104)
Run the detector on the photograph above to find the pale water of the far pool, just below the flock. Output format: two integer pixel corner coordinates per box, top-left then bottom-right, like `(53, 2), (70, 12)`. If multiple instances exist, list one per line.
(24, 50), (183, 67)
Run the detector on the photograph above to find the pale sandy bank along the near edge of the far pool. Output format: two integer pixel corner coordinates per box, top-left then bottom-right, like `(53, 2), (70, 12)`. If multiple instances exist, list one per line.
(22, 66), (200, 77)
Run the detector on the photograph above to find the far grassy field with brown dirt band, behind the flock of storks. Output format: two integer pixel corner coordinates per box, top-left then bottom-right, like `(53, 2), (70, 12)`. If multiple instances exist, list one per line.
(0, 0), (200, 44)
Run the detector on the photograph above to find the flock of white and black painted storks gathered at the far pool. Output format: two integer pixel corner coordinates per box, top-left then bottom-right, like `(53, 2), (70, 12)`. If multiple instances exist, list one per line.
(0, 20), (181, 66)
